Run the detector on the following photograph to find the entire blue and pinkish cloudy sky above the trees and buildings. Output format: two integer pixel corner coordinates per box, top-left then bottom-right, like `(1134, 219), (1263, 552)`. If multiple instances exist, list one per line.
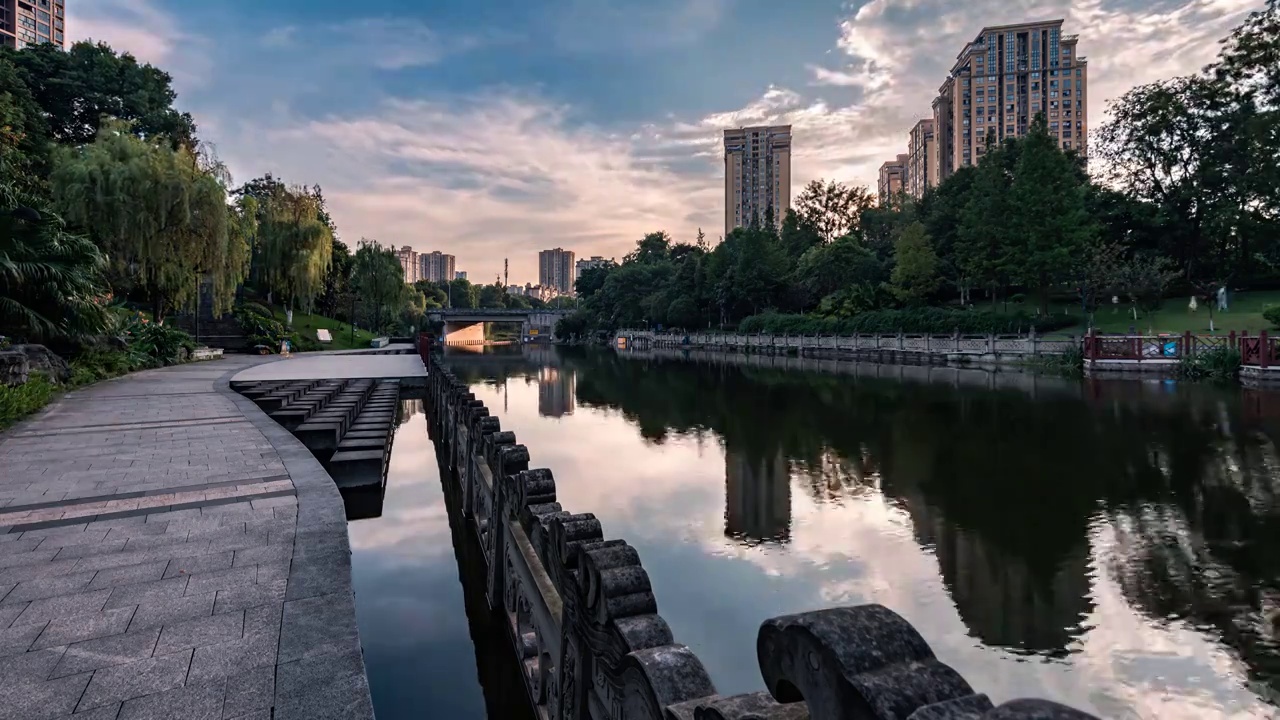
(68, 0), (1262, 282)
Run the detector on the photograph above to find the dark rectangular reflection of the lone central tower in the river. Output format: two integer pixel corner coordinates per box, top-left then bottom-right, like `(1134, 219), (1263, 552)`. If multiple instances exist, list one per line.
(724, 448), (791, 544)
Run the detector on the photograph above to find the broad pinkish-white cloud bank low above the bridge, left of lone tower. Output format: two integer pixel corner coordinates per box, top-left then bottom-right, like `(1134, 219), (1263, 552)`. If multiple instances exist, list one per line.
(219, 94), (721, 282)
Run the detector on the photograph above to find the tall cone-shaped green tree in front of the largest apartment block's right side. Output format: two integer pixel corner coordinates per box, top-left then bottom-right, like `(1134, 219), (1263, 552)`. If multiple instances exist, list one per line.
(1007, 114), (1096, 314)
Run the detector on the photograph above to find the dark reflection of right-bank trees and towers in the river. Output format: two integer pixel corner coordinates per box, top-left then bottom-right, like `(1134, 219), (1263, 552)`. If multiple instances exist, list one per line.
(437, 348), (1280, 697)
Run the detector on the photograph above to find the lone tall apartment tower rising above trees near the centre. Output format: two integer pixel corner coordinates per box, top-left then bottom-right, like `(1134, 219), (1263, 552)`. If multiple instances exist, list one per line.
(724, 126), (791, 234)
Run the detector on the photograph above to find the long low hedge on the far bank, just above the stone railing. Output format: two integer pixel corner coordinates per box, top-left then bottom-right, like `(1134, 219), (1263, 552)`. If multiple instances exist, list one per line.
(737, 307), (1075, 336)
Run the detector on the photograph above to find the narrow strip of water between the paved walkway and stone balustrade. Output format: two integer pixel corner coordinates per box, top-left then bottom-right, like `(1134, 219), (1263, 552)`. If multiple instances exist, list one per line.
(343, 400), (531, 720)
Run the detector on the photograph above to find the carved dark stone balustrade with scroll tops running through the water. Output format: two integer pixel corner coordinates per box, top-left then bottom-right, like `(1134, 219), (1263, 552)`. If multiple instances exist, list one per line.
(425, 355), (1096, 720)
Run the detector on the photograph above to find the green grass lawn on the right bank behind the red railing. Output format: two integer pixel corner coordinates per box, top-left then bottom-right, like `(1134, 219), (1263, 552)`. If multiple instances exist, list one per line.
(1028, 291), (1280, 336)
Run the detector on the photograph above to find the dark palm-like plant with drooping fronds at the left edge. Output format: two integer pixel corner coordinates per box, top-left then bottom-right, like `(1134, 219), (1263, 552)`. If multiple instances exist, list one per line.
(0, 173), (109, 342)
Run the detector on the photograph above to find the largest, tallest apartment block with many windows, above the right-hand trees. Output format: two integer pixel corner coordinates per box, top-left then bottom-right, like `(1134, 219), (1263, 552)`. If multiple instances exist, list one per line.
(933, 19), (1089, 182)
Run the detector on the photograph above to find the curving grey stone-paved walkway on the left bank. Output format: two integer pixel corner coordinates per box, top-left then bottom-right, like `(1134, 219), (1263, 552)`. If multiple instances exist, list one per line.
(0, 357), (372, 720)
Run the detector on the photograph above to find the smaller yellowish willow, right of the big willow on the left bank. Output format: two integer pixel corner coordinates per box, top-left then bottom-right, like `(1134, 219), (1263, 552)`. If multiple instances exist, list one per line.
(248, 182), (333, 310)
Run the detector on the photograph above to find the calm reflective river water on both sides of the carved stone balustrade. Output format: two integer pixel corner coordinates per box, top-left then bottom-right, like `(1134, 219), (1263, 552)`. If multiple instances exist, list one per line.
(351, 348), (1280, 720)
